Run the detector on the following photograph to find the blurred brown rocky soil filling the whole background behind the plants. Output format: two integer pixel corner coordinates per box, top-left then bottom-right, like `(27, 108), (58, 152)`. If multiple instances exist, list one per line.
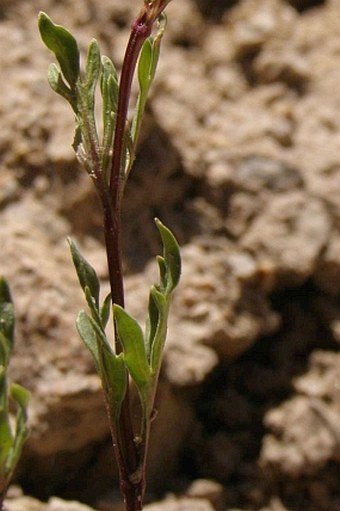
(0, 0), (340, 511)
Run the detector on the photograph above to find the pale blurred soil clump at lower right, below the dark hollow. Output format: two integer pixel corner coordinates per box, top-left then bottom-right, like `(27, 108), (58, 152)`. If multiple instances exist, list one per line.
(262, 351), (340, 477)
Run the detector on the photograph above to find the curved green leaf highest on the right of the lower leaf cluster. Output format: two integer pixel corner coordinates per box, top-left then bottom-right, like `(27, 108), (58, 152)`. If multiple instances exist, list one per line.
(155, 218), (181, 294)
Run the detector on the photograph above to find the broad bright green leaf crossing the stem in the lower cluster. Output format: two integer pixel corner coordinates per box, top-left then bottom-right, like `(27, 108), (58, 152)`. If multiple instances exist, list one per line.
(113, 304), (151, 391)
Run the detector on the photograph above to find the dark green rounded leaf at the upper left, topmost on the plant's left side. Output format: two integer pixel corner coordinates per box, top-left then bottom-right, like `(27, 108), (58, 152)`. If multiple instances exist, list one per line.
(38, 12), (80, 90)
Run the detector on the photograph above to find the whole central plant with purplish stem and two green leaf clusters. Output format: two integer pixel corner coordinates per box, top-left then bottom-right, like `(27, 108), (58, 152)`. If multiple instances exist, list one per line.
(39, 0), (181, 511)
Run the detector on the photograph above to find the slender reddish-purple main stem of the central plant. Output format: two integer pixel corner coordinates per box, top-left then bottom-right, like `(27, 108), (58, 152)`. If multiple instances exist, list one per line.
(101, 0), (169, 511)
